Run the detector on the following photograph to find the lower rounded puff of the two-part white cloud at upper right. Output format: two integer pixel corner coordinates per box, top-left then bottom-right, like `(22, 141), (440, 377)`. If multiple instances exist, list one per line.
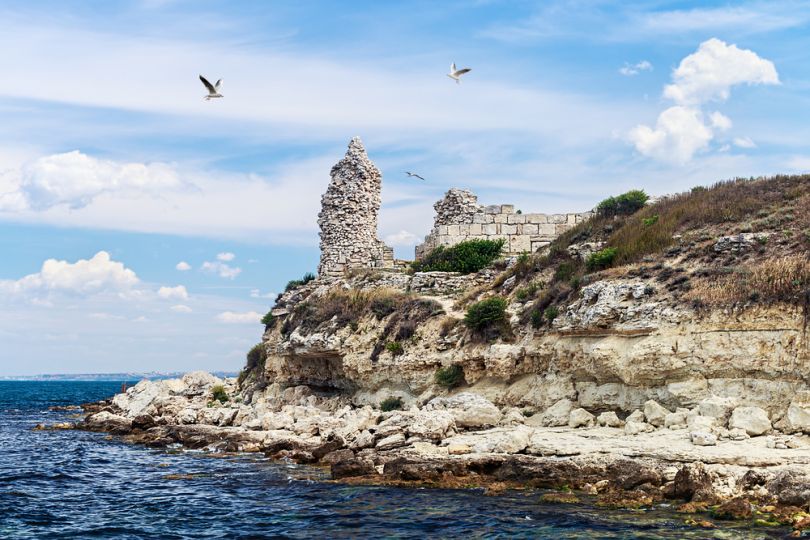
(629, 106), (713, 163)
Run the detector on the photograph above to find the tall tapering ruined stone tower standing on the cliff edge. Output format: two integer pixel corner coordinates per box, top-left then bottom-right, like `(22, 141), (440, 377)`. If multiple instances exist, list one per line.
(318, 137), (394, 277)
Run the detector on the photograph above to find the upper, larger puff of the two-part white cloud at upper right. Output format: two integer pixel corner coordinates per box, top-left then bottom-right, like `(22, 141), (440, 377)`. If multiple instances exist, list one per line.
(664, 38), (779, 105)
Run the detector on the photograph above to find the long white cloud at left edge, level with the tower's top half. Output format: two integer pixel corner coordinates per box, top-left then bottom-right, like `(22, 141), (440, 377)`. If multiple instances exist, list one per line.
(0, 150), (186, 212)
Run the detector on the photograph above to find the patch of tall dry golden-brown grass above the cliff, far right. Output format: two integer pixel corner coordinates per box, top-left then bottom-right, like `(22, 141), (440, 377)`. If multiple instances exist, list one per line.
(686, 254), (810, 306)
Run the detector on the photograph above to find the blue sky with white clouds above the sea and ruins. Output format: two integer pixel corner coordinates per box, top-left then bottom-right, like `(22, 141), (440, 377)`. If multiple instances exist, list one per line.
(0, 0), (810, 376)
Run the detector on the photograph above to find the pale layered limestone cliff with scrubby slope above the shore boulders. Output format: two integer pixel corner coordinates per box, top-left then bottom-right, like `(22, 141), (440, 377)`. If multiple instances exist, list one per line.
(254, 175), (810, 431)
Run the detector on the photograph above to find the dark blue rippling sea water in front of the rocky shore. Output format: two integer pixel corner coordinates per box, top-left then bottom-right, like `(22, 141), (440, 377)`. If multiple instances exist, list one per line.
(0, 382), (788, 539)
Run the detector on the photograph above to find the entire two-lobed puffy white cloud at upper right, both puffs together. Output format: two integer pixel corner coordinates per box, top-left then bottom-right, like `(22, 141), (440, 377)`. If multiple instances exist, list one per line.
(628, 38), (779, 164)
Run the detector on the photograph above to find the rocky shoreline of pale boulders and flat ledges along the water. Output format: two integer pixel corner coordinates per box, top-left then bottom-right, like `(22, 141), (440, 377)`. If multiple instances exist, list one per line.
(56, 372), (810, 536)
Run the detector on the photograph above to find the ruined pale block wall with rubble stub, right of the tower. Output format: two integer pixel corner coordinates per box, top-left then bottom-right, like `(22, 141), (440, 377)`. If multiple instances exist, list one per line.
(416, 189), (593, 258)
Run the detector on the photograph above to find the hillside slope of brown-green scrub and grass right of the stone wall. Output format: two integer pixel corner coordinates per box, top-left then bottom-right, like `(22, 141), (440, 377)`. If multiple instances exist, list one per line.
(495, 176), (810, 320)
